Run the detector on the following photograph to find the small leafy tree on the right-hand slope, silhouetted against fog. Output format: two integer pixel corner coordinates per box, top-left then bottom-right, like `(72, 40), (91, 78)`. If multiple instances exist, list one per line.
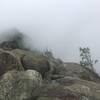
(80, 47), (98, 71)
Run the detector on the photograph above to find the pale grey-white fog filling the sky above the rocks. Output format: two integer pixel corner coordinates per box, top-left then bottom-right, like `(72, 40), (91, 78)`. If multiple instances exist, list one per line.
(0, 0), (100, 72)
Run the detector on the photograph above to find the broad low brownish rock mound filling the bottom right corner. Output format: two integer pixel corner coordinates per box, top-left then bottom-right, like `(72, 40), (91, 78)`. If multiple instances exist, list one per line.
(37, 77), (100, 100)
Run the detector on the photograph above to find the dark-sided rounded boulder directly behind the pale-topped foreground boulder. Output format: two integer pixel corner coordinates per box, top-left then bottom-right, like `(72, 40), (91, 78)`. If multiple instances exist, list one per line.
(21, 56), (50, 78)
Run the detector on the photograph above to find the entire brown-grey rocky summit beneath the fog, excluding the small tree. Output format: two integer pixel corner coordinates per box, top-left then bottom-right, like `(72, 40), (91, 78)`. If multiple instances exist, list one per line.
(0, 33), (100, 100)
